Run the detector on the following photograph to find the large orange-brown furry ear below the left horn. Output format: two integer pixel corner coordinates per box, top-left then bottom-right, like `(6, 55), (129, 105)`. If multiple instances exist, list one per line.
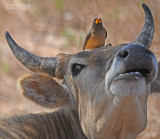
(19, 73), (69, 108)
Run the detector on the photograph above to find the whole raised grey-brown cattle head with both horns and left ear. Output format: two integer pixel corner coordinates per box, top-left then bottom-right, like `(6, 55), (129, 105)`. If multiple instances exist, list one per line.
(6, 4), (158, 139)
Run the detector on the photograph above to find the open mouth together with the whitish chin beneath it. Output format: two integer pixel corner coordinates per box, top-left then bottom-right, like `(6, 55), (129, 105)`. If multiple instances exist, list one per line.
(110, 68), (151, 96)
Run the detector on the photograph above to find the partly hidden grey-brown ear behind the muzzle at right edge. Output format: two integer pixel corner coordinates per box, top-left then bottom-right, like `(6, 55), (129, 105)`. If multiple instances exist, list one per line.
(151, 62), (160, 93)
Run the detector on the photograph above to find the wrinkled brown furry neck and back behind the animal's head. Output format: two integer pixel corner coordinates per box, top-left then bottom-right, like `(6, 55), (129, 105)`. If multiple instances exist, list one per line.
(0, 110), (86, 139)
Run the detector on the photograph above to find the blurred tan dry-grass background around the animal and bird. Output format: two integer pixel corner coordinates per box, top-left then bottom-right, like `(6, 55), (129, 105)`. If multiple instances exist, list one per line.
(0, 0), (160, 139)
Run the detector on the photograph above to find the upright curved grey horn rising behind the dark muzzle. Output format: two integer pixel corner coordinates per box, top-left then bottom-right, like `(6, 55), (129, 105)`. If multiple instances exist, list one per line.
(134, 3), (154, 48)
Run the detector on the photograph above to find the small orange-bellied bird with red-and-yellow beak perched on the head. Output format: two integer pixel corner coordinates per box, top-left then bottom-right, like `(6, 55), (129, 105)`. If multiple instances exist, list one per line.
(83, 18), (107, 50)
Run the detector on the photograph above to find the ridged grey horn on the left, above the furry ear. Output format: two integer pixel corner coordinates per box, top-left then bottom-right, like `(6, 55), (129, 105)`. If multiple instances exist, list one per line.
(5, 32), (58, 77)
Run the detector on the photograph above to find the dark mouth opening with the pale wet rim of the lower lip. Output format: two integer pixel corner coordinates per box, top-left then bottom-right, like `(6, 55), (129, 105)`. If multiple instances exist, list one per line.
(114, 68), (151, 81)
